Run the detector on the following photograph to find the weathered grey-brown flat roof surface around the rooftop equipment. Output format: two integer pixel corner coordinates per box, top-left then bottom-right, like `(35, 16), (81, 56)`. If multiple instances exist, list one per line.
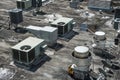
(0, 0), (120, 80)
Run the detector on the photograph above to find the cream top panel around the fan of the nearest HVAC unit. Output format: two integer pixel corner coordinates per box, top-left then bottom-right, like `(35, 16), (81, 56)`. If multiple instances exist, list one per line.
(12, 37), (44, 52)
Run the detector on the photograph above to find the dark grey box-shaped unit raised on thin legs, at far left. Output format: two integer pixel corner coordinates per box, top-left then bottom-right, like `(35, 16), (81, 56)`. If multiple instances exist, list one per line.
(9, 9), (23, 24)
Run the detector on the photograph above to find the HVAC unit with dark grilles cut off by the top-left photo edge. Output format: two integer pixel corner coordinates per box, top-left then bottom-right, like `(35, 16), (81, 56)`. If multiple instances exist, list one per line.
(16, 0), (32, 10)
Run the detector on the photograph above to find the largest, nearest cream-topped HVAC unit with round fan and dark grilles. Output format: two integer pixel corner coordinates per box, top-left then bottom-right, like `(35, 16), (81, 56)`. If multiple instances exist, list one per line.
(11, 37), (46, 67)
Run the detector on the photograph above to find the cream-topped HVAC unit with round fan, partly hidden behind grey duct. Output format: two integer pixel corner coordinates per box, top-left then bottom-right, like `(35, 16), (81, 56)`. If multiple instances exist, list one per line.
(51, 17), (74, 36)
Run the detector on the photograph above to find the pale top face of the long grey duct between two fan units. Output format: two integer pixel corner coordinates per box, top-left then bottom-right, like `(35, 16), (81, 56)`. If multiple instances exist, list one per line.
(27, 25), (57, 32)
